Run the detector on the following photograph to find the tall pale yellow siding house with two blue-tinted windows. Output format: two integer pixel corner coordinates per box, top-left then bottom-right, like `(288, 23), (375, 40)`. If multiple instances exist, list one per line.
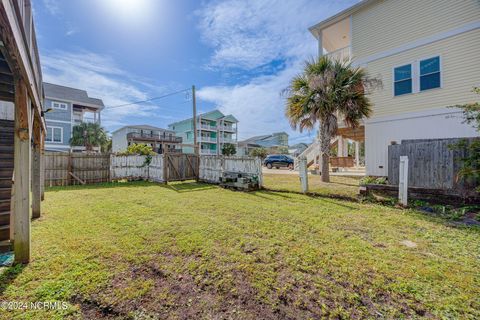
(310, 0), (480, 176)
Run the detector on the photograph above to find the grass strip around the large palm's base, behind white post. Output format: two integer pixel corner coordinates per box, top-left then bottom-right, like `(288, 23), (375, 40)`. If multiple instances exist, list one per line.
(263, 173), (361, 198)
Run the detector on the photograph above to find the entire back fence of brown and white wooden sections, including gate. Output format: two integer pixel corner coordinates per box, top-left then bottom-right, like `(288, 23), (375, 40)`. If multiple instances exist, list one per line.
(44, 152), (262, 187)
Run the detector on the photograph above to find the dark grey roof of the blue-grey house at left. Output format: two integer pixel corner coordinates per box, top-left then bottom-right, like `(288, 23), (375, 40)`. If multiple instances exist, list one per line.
(43, 82), (105, 109)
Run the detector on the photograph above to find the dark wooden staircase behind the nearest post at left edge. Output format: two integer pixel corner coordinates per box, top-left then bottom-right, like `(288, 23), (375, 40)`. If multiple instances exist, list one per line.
(0, 120), (14, 253)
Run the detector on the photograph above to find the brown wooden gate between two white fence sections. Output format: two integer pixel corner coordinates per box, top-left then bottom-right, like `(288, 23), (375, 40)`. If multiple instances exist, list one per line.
(163, 153), (200, 182)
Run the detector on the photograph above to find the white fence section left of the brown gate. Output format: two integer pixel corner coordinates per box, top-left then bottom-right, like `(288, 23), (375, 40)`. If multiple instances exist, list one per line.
(110, 155), (164, 182)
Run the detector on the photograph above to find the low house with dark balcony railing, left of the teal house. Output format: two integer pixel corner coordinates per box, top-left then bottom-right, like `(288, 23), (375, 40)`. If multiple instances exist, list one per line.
(112, 125), (182, 154)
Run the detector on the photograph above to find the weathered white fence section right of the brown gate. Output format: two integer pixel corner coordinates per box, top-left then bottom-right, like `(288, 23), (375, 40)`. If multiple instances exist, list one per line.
(199, 156), (263, 186)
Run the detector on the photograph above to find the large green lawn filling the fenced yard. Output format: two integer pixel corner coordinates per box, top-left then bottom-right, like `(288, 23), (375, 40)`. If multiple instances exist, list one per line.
(0, 181), (480, 319)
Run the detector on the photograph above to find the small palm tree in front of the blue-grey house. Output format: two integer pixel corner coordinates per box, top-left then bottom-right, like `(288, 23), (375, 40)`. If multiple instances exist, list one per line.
(70, 122), (108, 151)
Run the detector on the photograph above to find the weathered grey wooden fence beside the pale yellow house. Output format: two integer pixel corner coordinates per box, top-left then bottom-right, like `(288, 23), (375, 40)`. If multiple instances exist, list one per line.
(388, 138), (478, 193)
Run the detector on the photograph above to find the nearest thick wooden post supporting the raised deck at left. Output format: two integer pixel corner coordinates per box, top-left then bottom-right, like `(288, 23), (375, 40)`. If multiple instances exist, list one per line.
(13, 80), (31, 263)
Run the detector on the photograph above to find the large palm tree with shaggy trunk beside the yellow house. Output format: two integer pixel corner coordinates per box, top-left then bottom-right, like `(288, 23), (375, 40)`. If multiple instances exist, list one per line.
(286, 56), (381, 182)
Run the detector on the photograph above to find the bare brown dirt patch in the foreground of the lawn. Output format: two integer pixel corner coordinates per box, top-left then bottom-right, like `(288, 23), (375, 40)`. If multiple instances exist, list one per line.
(72, 249), (432, 320)
